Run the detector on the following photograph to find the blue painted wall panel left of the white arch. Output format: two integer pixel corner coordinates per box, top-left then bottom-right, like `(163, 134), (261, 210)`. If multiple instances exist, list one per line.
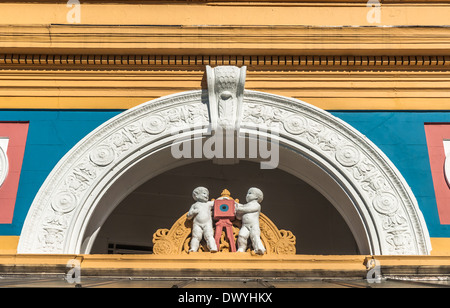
(0, 110), (121, 235)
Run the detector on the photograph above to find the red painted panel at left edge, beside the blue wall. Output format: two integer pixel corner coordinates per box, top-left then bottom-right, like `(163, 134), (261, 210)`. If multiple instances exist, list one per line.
(0, 122), (28, 224)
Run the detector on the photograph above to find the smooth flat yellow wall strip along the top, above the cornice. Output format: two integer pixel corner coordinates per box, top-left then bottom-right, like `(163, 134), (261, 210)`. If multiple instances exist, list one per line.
(0, 0), (450, 26)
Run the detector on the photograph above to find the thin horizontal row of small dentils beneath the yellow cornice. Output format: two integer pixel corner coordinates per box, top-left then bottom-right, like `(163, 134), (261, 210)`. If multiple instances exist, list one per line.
(0, 54), (450, 71)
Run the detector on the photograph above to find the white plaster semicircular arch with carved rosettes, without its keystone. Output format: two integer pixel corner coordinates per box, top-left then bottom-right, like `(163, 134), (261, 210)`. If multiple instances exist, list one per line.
(18, 90), (431, 255)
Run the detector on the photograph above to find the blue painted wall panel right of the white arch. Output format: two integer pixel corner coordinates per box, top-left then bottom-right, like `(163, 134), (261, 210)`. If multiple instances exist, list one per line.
(331, 111), (450, 237)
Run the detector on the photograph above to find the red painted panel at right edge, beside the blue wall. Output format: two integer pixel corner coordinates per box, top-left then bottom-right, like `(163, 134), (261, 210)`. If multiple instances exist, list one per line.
(425, 124), (450, 224)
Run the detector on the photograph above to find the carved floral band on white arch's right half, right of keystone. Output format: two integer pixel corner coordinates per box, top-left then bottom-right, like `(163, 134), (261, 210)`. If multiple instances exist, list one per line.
(242, 93), (422, 255)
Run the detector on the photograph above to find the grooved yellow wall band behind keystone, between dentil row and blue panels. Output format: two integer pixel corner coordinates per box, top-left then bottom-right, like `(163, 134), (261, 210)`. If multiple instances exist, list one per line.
(0, 67), (450, 110)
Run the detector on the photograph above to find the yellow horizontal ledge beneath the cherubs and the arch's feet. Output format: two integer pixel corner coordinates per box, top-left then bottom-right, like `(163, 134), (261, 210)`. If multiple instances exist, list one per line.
(0, 253), (450, 279)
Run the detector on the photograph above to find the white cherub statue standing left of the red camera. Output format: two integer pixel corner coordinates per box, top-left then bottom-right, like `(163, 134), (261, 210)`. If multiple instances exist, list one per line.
(187, 187), (217, 252)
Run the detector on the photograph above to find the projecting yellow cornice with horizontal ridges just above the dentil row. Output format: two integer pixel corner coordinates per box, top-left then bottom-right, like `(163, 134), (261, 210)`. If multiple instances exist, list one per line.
(0, 24), (450, 57)
